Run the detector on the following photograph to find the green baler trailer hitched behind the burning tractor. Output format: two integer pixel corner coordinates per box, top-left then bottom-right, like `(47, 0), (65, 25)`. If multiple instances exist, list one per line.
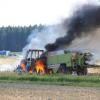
(47, 50), (87, 75)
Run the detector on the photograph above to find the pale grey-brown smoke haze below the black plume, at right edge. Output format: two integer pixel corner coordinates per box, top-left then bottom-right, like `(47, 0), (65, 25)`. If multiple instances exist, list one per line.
(69, 28), (100, 65)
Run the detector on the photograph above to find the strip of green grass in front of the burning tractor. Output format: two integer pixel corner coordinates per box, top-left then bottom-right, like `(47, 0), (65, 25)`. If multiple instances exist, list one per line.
(0, 73), (100, 87)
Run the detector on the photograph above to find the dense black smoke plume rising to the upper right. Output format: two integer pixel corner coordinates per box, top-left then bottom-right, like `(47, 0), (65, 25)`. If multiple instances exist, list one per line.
(45, 5), (100, 51)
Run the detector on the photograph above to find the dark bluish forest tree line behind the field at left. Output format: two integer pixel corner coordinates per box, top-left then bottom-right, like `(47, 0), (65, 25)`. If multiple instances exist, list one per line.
(0, 25), (44, 52)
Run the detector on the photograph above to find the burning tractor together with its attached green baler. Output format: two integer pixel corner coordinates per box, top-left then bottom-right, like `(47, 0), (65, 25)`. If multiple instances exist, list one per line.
(17, 50), (91, 75)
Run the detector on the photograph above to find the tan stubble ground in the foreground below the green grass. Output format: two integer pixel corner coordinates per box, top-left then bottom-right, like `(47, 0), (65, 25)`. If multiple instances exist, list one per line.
(0, 83), (100, 100)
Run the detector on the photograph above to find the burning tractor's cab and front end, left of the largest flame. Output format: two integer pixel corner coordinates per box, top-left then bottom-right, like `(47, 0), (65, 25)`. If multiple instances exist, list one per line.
(18, 49), (44, 73)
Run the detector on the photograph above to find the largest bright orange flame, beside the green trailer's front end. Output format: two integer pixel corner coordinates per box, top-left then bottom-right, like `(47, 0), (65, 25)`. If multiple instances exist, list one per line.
(35, 60), (45, 74)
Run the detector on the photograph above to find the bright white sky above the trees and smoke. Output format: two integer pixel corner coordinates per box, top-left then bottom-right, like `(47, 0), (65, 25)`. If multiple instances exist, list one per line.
(0, 0), (99, 26)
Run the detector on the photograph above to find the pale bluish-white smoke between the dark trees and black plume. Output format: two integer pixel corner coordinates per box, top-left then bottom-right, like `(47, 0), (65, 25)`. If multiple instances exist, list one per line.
(23, 25), (65, 54)
